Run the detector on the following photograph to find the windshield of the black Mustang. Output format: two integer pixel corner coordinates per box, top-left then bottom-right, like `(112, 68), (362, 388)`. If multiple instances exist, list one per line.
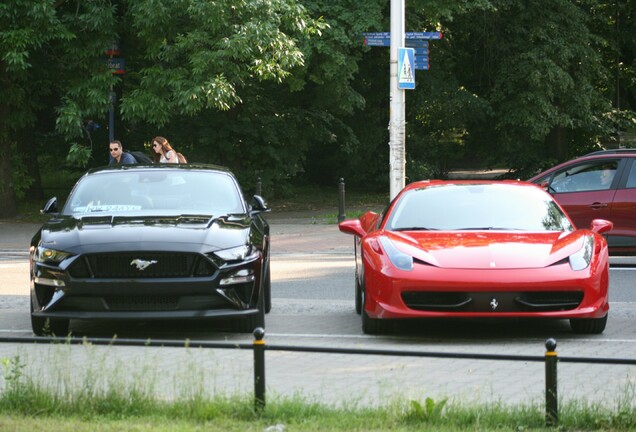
(62, 169), (245, 216)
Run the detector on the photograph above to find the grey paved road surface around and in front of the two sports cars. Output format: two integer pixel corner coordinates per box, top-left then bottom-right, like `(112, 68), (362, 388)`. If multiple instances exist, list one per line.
(0, 219), (636, 405)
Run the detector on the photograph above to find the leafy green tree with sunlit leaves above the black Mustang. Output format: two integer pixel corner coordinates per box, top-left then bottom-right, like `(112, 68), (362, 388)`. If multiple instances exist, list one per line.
(0, 0), (321, 217)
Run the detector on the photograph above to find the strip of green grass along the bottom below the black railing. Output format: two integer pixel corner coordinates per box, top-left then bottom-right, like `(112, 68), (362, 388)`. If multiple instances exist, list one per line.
(0, 389), (636, 431)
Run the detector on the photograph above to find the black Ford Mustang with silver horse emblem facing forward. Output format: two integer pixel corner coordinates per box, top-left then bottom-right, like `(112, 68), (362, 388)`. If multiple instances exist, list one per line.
(30, 164), (271, 336)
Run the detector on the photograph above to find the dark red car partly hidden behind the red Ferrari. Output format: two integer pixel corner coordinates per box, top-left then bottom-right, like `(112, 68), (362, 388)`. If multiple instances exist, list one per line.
(528, 149), (636, 255)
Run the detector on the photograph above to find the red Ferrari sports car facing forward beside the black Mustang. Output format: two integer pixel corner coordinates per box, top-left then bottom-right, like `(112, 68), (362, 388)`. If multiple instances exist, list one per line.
(339, 180), (612, 334)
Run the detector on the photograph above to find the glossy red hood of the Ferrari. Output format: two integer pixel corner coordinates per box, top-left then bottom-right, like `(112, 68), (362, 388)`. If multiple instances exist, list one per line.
(389, 231), (585, 269)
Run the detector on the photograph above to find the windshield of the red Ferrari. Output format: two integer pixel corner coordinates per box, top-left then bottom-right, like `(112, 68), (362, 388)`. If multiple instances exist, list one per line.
(386, 184), (574, 231)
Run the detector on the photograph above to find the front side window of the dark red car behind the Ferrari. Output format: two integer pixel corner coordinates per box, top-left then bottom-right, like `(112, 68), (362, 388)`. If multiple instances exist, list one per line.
(550, 159), (618, 193)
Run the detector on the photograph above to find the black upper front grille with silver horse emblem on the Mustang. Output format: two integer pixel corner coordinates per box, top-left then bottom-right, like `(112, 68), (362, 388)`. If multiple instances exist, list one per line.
(69, 252), (215, 279)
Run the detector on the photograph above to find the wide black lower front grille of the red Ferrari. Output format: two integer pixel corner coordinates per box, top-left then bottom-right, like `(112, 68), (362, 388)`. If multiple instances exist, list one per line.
(402, 291), (583, 313)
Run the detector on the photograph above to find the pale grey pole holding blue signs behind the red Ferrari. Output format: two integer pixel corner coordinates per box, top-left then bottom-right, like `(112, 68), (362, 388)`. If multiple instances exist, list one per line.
(389, 0), (406, 200)
